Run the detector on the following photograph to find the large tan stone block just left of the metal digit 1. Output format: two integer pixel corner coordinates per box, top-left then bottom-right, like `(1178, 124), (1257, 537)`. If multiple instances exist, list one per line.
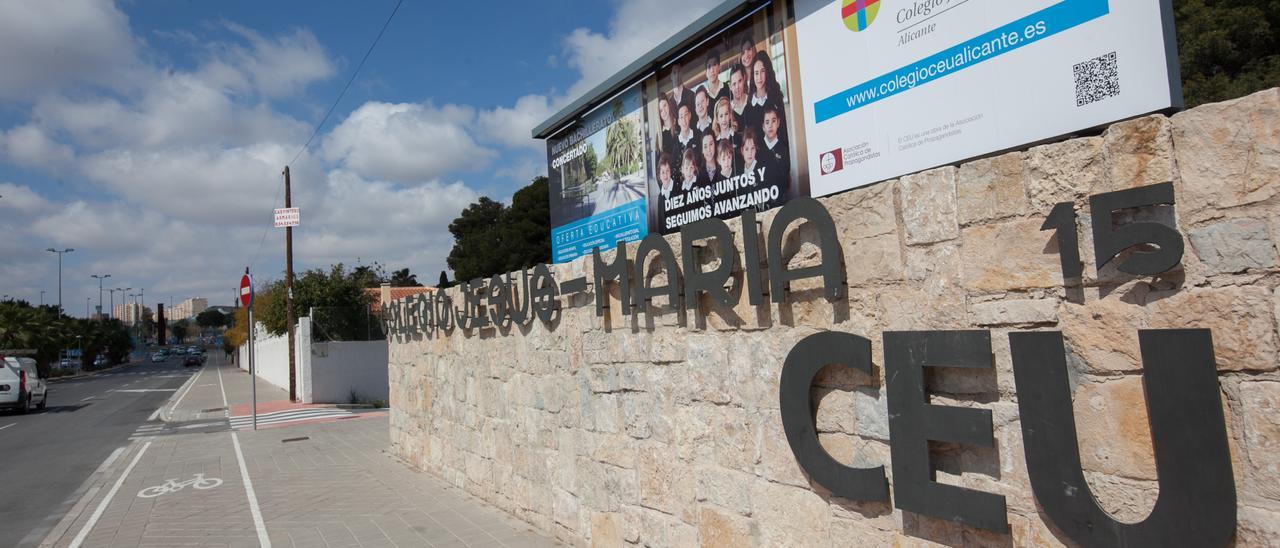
(960, 219), (1062, 292)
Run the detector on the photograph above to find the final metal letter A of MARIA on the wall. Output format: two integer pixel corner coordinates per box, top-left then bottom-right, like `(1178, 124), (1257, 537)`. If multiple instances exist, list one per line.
(768, 197), (845, 302)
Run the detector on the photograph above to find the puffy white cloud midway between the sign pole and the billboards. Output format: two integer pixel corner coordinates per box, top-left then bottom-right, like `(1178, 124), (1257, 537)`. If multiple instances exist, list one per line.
(324, 102), (495, 182)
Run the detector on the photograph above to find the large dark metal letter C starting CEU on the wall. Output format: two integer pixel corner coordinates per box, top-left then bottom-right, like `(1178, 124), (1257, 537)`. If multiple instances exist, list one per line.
(778, 332), (888, 501)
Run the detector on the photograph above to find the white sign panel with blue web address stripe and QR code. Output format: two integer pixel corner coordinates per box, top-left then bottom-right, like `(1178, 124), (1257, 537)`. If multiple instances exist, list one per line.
(795, 0), (1181, 196)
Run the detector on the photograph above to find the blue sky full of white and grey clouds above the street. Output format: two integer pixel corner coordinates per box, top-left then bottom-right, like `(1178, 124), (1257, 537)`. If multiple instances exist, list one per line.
(0, 0), (716, 315)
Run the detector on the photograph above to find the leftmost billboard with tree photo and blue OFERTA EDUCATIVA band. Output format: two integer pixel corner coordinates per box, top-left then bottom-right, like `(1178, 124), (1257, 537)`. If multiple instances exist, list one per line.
(547, 86), (648, 262)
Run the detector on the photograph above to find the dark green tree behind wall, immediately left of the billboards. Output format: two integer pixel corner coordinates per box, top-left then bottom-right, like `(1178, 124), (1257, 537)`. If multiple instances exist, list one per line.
(448, 177), (552, 280)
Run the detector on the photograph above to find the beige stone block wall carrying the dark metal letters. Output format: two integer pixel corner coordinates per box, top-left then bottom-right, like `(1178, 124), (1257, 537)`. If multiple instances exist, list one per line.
(390, 90), (1280, 545)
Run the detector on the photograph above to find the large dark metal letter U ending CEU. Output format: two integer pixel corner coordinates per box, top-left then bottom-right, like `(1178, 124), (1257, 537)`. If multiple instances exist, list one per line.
(1013, 329), (1235, 547)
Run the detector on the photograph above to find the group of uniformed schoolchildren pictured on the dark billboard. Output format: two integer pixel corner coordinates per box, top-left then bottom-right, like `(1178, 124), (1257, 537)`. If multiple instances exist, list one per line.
(655, 33), (791, 225)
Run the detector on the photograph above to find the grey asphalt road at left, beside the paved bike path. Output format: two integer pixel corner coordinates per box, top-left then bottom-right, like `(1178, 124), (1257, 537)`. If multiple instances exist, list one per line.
(0, 357), (198, 547)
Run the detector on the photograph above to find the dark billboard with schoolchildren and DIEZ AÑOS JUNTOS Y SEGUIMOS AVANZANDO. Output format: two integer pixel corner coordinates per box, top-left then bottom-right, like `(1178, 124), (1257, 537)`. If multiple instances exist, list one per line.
(646, 3), (808, 234)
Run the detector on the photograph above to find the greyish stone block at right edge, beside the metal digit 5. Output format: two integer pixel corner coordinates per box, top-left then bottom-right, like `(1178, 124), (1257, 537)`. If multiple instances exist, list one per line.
(1188, 219), (1277, 274)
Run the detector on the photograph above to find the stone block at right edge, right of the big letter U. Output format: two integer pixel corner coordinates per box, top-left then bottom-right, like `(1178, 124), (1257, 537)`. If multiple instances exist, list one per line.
(1236, 380), (1280, 501)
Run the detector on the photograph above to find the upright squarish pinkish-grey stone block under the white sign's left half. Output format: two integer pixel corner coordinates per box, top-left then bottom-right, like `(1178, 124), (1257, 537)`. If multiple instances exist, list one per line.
(901, 166), (960, 246)
